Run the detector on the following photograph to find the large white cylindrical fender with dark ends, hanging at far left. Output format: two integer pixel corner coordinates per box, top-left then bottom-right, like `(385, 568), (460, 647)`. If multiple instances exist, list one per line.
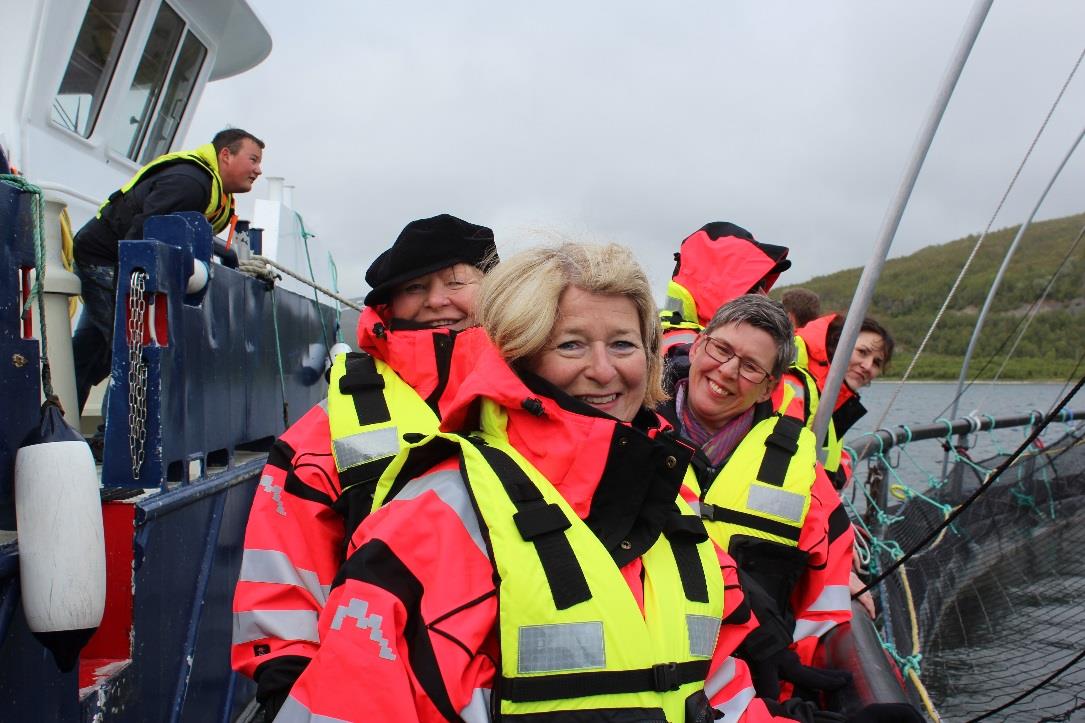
(15, 440), (105, 669)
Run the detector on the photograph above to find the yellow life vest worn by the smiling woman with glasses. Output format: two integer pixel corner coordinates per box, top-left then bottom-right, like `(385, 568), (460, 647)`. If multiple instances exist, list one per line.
(701, 415), (817, 549)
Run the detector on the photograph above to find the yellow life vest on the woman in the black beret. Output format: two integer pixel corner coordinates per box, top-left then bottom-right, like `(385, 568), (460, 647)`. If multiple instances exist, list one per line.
(328, 353), (441, 493)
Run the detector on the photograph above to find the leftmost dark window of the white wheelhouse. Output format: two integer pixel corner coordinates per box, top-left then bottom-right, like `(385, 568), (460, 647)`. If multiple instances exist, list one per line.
(51, 0), (139, 138)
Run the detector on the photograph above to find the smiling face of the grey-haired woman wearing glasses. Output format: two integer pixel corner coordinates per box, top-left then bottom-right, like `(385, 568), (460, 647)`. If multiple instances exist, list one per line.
(686, 322), (776, 432)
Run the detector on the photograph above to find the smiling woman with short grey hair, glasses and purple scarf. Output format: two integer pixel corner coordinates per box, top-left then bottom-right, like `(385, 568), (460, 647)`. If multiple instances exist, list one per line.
(660, 294), (853, 716)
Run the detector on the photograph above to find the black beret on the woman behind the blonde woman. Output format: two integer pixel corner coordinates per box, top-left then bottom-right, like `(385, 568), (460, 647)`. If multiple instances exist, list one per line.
(366, 214), (497, 306)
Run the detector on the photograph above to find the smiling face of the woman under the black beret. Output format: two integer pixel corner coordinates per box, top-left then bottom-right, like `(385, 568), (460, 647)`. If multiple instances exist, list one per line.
(388, 264), (482, 331)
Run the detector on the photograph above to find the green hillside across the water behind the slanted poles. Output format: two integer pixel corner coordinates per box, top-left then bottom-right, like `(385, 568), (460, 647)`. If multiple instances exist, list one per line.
(773, 214), (1085, 380)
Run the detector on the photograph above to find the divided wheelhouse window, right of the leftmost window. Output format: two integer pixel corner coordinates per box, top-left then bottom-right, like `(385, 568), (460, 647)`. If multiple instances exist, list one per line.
(110, 3), (207, 163)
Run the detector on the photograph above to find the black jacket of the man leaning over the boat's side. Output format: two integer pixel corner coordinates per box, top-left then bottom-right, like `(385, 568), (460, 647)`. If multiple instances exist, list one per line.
(75, 162), (212, 266)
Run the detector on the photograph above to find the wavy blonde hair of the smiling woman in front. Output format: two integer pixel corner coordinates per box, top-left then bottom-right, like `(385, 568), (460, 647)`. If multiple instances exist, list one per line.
(478, 242), (666, 408)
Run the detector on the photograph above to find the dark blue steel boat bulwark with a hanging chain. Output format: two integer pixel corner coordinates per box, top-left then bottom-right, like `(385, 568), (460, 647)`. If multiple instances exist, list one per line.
(102, 213), (351, 489)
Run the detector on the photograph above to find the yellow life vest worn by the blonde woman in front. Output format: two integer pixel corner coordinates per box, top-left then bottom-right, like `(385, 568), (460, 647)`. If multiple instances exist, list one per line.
(374, 399), (724, 723)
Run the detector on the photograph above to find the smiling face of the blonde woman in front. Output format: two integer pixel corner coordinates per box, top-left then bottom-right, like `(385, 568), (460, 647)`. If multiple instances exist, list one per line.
(525, 287), (648, 421)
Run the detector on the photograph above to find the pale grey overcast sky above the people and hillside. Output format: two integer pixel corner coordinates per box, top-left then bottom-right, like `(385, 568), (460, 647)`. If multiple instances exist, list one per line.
(188, 0), (1085, 296)
